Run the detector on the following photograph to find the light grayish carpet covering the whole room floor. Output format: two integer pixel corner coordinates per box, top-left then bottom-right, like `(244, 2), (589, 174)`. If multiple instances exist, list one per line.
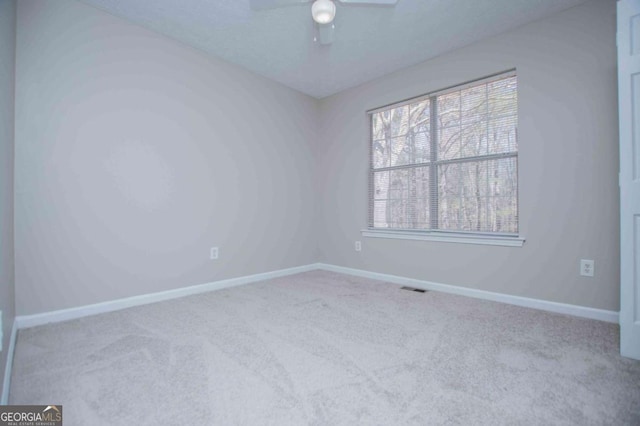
(10, 271), (640, 426)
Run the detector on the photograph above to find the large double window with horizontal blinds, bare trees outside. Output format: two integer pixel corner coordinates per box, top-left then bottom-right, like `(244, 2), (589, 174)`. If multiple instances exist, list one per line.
(369, 71), (518, 245)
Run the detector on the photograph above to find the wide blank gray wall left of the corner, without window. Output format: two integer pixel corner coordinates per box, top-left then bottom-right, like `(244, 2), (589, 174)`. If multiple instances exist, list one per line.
(15, 0), (318, 315)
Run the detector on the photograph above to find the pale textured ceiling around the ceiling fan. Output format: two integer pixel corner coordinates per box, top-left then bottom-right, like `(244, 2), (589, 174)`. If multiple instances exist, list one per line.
(81, 0), (585, 98)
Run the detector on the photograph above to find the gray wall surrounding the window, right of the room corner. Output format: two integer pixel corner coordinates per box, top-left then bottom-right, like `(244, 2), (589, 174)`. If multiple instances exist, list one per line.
(317, 0), (619, 311)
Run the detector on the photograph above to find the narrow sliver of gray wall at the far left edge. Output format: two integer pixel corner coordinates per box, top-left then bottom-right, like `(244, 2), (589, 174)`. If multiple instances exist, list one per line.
(0, 0), (16, 392)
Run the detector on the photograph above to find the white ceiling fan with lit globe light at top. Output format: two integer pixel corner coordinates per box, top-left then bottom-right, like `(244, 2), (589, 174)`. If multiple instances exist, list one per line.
(251, 0), (398, 45)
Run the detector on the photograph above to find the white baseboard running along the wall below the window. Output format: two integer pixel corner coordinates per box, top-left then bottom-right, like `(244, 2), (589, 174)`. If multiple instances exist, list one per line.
(318, 263), (619, 324)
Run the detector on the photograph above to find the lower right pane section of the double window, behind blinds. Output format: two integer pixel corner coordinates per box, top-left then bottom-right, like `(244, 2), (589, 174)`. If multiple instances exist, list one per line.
(438, 158), (518, 233)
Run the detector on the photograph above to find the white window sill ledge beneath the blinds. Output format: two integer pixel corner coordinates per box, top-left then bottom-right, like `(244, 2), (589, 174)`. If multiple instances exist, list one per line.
(362, 229), (525, 247)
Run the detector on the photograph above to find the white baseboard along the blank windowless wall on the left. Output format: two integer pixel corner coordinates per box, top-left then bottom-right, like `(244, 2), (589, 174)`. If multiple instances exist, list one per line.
(15, 263), (318, 329)
